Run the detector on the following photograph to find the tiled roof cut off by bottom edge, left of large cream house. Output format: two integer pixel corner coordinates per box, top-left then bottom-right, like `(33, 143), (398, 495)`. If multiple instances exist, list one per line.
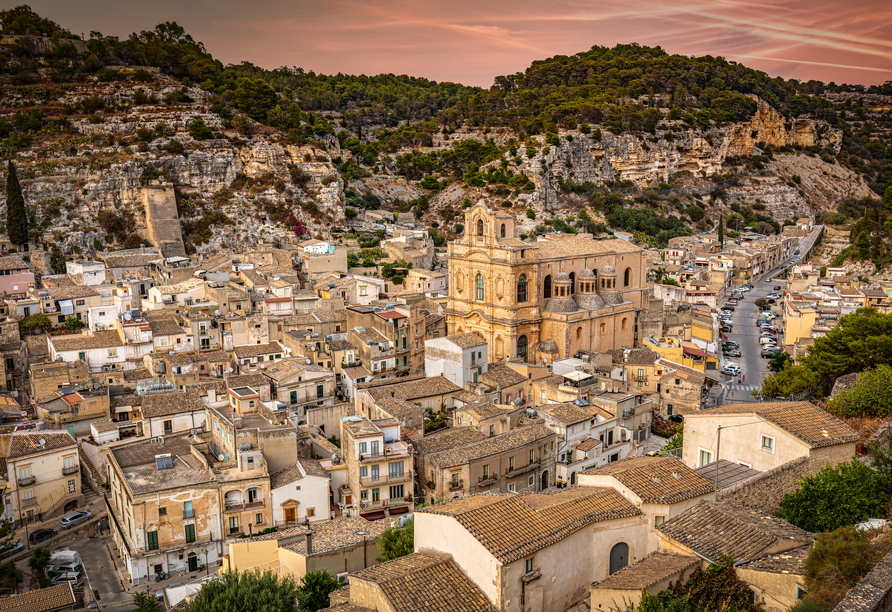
(350, 552), (495, 612)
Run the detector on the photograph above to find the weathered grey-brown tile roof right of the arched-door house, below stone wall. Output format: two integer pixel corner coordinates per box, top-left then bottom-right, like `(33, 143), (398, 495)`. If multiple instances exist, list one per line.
(658, 501), (814, 562)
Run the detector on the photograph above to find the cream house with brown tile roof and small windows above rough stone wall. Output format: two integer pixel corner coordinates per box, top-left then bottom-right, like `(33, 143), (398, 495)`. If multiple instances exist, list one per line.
(682, 402), (861, 471)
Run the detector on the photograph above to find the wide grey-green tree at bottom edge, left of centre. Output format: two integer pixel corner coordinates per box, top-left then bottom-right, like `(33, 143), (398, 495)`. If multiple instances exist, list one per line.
(185, 572), (304, 612)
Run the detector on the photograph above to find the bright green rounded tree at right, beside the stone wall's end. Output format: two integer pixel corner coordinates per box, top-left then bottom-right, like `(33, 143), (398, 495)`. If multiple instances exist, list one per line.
(781, 459), (889, 533)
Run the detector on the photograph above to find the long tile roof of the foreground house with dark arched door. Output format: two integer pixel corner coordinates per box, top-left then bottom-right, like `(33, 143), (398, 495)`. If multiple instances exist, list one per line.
(426, 487), (641, 563)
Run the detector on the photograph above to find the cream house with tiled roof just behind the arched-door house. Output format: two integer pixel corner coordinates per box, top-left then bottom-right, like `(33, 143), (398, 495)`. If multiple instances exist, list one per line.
(577, 457), (715, 552)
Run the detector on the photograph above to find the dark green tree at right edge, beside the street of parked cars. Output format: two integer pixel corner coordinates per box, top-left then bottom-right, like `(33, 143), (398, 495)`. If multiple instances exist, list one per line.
(802, 308), (892, 390)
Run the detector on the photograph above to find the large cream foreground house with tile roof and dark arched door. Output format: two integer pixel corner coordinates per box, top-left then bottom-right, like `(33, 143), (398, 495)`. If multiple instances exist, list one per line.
(415, 487), (647, 612)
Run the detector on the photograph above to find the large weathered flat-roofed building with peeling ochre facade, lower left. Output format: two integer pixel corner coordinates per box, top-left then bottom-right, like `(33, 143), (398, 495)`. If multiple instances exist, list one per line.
(107, 432), (272, 584)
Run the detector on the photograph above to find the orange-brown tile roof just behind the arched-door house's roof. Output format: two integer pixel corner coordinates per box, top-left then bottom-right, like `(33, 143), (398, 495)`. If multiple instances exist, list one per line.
(582, 457), (715, 504)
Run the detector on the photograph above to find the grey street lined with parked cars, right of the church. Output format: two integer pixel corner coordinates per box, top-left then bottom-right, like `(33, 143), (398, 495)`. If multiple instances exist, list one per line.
(718, 226), (821, 405)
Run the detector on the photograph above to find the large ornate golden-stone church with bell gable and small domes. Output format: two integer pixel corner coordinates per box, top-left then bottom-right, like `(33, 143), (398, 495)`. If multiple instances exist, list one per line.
(446, 204), (646, 363)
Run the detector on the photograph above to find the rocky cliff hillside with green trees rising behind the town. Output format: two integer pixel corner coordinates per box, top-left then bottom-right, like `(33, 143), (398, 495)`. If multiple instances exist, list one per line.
(0, 7), (892, 262)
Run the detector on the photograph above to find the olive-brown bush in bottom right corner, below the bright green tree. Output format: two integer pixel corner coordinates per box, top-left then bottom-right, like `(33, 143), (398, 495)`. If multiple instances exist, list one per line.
(803, 527), (879, 610)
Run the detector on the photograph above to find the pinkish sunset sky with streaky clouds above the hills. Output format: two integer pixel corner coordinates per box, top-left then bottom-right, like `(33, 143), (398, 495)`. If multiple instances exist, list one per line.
(27, 0), (892, 87)
